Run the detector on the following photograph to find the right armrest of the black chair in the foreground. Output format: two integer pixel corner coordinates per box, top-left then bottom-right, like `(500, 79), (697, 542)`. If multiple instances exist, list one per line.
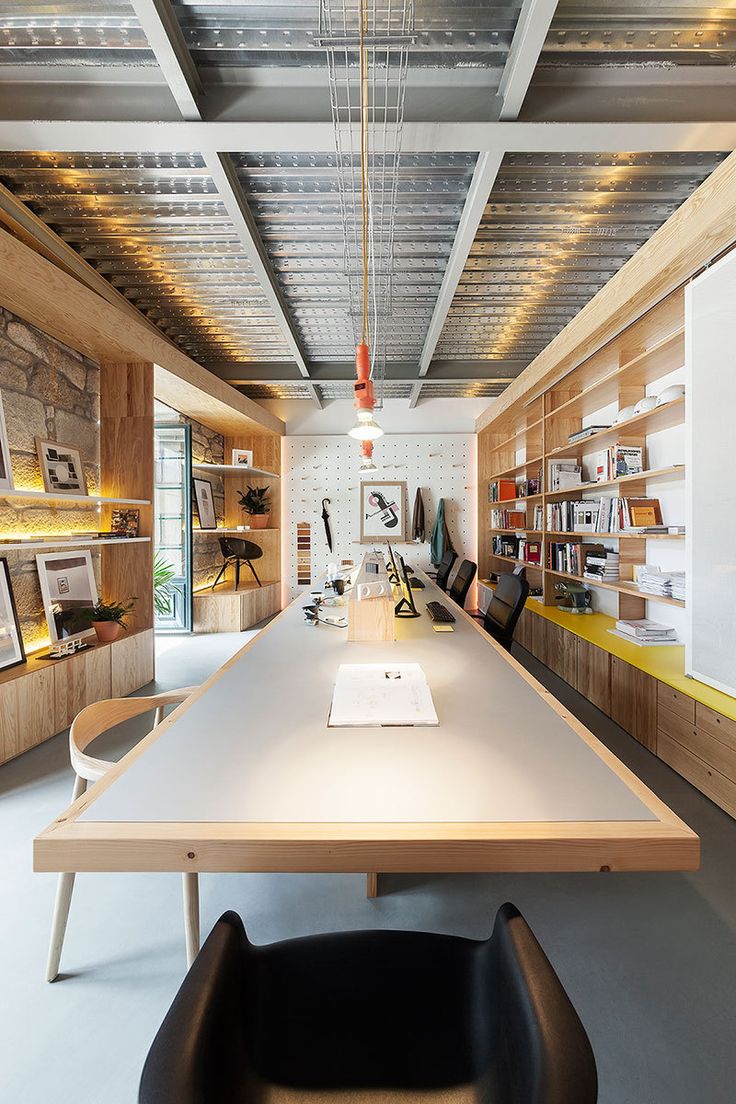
(491, 904), (598, 1104)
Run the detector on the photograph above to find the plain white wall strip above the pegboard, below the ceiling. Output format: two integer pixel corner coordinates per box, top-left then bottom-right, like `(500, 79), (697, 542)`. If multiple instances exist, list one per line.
(259, 399), (497, 432)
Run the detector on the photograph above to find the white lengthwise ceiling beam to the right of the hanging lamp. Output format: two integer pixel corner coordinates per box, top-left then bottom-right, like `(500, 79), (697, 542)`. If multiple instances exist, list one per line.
(409, 0), (557, 410)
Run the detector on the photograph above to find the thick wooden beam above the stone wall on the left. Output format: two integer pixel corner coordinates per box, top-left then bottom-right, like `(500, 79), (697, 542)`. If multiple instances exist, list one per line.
(0, 231), (285, 436)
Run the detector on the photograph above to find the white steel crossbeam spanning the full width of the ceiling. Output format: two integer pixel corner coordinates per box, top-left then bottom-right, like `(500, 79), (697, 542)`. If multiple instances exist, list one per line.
(0, 119), (736, 153)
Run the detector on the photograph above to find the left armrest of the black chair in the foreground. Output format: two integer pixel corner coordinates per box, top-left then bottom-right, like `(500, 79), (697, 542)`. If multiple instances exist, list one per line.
(138, 912), (247, 1104)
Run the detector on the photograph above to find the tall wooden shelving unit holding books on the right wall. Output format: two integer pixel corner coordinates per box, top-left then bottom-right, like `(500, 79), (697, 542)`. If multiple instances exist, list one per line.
(478, 288), (685, 617)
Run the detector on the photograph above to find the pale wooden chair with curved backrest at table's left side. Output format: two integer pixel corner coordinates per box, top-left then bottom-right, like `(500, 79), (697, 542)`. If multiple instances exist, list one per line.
(46, 687), (200, 981)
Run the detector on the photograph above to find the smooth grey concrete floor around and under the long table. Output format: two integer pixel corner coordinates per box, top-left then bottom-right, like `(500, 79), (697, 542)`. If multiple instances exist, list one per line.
(0, 634), (736, 1104)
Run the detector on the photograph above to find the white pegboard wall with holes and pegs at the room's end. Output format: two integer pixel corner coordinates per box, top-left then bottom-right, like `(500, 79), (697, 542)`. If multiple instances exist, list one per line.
(281, 433), (476, 597)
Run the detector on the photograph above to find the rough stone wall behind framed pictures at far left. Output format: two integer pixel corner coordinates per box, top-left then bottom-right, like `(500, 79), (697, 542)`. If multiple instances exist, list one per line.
(0, 309), (99, 649)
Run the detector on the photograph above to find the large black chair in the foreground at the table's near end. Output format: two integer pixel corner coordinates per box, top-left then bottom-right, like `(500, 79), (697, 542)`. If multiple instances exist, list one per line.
(138, 904), (598, 1104)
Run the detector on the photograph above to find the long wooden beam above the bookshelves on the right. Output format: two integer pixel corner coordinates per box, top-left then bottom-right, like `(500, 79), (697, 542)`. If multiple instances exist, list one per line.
(476, 153), (736, 433)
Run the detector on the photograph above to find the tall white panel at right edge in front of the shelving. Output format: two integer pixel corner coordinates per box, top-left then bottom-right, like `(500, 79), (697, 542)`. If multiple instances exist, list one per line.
(685, 251), (736, 696)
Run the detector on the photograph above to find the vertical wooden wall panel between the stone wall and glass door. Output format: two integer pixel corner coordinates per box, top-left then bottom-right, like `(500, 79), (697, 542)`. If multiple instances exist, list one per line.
(99, 361), (153, 631)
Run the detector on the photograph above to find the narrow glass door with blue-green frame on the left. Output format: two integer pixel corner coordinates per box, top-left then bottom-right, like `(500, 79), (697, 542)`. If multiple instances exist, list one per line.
(153, 422), (192, 633)
